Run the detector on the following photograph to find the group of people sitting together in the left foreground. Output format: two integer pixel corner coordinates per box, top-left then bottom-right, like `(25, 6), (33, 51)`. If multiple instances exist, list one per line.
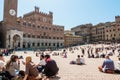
(0, 50), (59, 80)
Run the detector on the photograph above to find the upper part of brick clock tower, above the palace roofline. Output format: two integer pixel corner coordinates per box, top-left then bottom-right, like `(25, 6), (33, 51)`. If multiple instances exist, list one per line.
(3, 0), (18, 23)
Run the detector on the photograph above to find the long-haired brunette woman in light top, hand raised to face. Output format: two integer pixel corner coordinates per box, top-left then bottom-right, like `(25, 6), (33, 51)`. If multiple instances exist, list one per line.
(6, 55), (20, 78)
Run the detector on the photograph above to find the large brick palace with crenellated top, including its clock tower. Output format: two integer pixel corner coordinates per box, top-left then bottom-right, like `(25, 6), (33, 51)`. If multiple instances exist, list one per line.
(0, 0), (64, 48)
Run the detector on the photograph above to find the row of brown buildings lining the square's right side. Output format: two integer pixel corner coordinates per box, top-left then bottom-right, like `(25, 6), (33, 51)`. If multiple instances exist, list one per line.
(71, 16), (120, 43)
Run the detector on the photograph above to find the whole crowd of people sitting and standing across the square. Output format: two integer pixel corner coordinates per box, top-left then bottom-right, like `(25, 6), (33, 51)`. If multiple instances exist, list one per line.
(0, 45), (120, 80)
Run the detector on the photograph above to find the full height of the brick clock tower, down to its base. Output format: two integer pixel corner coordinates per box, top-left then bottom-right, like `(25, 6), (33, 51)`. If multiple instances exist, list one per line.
(0, 0), (18, 48)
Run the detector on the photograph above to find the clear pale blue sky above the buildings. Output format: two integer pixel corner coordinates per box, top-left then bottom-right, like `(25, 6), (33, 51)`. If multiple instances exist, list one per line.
(0, 0), (120, 30)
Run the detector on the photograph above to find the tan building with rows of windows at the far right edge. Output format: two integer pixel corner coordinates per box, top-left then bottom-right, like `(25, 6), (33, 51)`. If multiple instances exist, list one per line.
(105, 16), (120, 43)
